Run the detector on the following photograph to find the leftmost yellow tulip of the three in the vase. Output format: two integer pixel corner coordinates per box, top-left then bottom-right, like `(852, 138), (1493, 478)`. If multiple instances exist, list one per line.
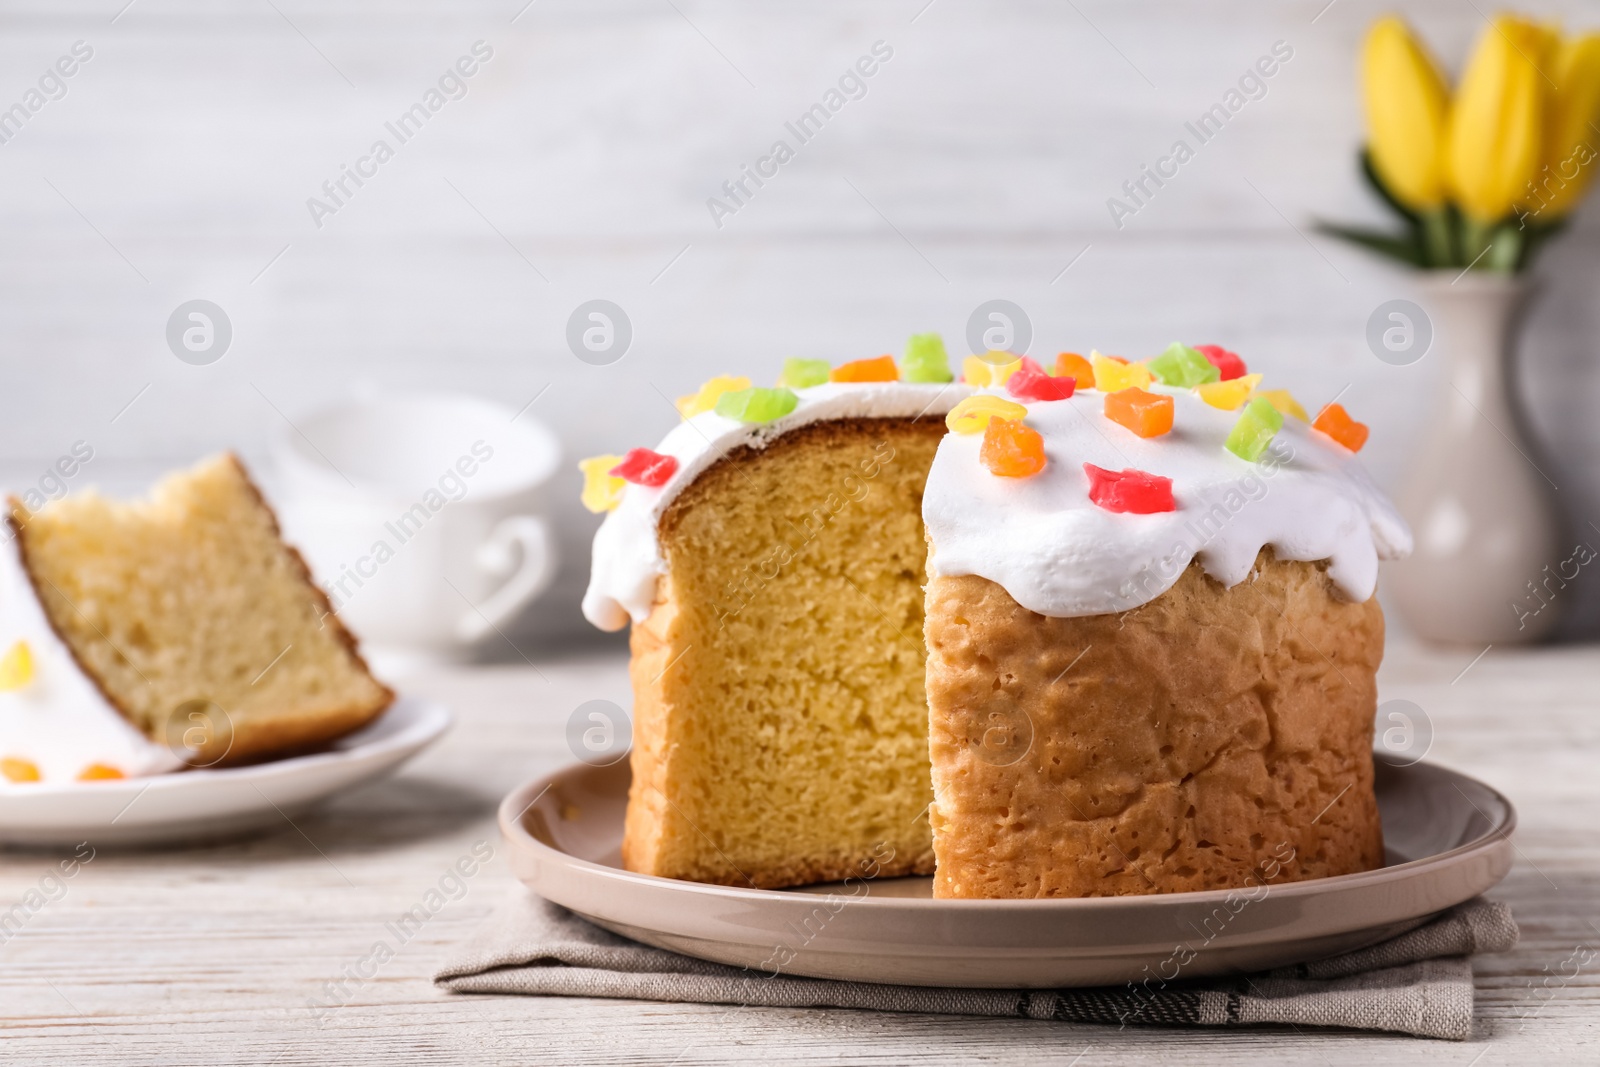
(1362, 14), (1450, 211)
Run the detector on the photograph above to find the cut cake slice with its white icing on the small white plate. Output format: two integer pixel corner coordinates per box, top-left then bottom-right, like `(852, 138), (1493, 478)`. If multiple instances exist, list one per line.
(0, 456), (394, 785)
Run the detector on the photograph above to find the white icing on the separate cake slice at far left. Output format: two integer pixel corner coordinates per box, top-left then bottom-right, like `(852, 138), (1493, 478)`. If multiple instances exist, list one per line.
(0, 525), (182, 789)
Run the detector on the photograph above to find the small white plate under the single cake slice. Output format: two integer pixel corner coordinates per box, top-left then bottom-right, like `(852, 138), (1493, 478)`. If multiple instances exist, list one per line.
(0, 696), (450, 846)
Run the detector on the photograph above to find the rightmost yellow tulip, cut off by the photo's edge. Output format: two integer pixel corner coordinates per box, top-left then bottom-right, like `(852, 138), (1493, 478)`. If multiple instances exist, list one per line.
(1523, 34), (1600, 222)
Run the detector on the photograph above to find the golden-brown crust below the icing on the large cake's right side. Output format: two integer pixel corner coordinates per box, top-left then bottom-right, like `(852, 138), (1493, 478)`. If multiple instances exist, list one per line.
(926, 550), (1384, 897)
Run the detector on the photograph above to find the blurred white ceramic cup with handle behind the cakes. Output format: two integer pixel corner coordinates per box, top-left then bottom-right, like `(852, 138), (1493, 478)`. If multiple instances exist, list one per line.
(272, 392), (560, 657)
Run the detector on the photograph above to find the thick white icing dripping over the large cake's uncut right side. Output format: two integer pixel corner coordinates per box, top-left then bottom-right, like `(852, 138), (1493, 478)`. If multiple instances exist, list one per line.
(922, 386), (1411, 617)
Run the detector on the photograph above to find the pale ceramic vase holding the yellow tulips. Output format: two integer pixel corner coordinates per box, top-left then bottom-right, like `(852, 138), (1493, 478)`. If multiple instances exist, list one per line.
(1386, 270), (1576, 646)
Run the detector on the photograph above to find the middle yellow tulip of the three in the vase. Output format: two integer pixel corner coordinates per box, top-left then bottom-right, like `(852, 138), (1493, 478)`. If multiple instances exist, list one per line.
(1445, 14), (1555, 224)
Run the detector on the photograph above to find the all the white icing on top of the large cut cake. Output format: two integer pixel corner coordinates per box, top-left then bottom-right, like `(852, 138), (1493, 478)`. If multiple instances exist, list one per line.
(584, 382), (1411, 630)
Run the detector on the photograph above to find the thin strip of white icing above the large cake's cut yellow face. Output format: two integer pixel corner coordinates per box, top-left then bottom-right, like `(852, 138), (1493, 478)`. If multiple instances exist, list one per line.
(584, 382), (973, 630)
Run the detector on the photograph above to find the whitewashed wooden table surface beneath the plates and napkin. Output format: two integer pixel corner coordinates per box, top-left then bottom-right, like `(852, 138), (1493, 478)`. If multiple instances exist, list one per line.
(0, 645), (1600, 1067)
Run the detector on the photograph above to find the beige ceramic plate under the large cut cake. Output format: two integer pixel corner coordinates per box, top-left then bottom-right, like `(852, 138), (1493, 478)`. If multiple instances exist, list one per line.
(499, 760), (1517, 989)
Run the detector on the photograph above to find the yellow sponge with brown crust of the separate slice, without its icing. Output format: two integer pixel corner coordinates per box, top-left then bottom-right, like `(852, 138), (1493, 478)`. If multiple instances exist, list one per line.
(10, 456), (394, 766)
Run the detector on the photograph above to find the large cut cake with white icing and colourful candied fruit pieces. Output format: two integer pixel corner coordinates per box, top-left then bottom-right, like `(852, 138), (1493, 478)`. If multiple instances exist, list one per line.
(582, 334), (1410, 897)
